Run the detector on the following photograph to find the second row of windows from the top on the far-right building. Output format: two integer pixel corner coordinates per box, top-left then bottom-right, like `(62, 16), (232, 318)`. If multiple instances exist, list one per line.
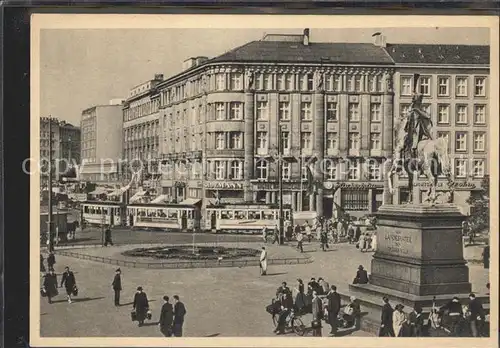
(401, 104), (486, 125)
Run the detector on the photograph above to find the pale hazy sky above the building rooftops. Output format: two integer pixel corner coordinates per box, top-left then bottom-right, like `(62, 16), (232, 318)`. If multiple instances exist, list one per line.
(40, 27), (489, 126)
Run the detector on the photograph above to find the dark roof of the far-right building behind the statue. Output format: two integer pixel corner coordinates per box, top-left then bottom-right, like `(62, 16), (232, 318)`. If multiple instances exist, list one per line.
(386, 44), (490, 65)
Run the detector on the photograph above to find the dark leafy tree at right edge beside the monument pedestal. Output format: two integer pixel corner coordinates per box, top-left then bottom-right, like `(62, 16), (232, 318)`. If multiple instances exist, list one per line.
(467, 176), (490, 233)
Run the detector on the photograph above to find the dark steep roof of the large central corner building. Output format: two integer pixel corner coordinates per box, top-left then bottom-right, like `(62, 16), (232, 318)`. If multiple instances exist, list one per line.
(207, 41), (393, 64)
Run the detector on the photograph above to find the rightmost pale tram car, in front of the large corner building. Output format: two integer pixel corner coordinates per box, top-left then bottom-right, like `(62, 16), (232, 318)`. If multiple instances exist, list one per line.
(205, 203), (293, 234)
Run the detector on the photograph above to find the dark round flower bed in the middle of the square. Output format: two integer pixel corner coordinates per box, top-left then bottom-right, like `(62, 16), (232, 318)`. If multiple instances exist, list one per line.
(122, 245), (260, 260)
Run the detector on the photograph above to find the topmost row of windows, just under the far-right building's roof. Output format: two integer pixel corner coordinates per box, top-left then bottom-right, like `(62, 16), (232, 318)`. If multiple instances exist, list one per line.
(401, 76), (486, 97)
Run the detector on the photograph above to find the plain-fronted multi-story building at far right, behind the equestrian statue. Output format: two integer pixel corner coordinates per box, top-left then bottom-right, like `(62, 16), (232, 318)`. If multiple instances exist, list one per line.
(381, 38), (490, 213)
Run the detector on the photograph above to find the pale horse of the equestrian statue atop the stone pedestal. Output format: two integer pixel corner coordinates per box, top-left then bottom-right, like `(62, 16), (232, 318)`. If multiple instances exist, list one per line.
(388, 112), (453, 205)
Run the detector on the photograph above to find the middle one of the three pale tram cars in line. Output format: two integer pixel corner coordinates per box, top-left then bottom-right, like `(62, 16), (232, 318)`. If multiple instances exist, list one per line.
(127, 203), (201, 231)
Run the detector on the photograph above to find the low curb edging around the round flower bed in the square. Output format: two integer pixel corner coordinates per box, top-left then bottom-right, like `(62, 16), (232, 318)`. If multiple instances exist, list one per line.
(56, 243), (314, 269)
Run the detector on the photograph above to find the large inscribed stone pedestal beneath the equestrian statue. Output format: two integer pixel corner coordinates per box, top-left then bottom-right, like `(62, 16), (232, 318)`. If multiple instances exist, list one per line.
(349, 204), (472, 334)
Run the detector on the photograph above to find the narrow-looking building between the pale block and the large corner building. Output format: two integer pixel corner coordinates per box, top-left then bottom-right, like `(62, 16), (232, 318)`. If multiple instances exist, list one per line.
(123, 74), (163, 188)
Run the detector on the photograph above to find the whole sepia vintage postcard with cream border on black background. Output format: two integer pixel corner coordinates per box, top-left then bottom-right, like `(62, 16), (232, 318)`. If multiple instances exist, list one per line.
(30, 14), (499, 347)
